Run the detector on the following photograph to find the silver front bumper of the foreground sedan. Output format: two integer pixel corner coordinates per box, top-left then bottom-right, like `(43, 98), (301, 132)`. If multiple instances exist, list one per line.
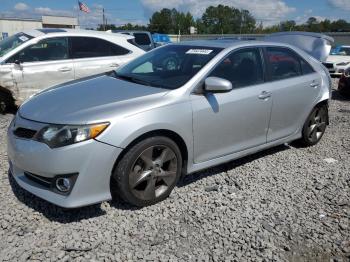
(7, 119), (122, 208)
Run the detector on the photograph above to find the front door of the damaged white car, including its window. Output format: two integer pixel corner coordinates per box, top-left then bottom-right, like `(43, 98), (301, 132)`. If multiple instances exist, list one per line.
(7, 37), (74, 101)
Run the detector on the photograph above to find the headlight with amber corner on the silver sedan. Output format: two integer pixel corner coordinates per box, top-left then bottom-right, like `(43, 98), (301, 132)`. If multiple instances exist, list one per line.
(35, 123), (109, 148)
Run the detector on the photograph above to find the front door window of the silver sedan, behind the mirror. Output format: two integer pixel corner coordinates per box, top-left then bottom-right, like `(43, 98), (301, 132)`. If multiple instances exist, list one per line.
(210, 48), (264, 88)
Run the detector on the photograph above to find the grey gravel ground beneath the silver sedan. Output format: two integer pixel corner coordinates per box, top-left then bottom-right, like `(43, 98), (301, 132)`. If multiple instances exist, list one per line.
(0, 81), (350, 261)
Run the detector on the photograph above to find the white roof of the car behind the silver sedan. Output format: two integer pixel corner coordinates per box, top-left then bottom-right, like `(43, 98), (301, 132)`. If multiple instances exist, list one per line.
(23, 28), (134, 39)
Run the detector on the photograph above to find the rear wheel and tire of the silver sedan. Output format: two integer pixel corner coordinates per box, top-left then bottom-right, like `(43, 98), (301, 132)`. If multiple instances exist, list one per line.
(299, 105), (328, 147)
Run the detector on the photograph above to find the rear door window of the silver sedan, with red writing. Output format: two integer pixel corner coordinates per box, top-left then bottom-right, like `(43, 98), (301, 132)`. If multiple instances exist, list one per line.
(267, 47), (302, 80)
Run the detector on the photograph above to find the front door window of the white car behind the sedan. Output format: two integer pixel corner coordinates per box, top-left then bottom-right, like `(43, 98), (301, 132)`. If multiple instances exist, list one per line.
(8, 37), (69, 63)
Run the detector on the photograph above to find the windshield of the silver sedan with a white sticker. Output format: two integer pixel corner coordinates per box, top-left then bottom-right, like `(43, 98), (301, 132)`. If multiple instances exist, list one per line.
(116, 45), (222, 89)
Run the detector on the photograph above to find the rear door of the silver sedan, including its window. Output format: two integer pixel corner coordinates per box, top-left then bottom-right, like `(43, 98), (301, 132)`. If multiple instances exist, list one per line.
(265, 47), (322, 142)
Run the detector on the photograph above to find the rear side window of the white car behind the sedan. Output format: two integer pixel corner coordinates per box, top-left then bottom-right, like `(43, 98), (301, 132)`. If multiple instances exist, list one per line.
(70, 37), (130, 58)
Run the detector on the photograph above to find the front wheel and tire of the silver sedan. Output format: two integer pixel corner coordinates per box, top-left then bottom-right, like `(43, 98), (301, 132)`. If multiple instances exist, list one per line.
(112, 136), (182, 207)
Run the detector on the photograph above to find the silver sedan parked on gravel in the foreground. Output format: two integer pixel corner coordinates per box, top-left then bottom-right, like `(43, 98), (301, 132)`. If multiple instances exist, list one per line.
(8, 40), (331, 208)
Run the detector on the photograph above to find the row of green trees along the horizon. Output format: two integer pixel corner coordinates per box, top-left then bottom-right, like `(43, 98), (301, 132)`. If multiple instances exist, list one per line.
(97, 5), (350, 34)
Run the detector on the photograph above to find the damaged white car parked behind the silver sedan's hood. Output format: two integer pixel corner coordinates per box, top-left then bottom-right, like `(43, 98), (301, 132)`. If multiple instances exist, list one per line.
(0, 29), (145, 111)
